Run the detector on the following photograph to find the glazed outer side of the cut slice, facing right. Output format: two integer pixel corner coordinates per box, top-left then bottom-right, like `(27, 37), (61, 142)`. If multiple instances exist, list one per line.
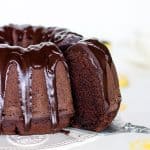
(86, 39), (121, 110)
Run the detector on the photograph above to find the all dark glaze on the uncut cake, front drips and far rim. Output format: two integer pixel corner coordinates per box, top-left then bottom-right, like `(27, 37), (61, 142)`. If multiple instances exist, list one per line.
(0, 24), (82, 129)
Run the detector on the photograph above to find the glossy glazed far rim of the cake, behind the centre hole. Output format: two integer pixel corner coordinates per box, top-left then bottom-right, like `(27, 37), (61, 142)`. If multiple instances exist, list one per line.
(0, 24), (83, 50)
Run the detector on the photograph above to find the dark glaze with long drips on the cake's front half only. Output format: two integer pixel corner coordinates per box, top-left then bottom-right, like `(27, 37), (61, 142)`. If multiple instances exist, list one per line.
(0, 42), (64, 129)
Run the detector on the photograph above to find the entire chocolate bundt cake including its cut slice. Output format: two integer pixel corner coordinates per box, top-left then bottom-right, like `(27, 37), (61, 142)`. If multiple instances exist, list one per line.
(0, 25), (121, 135)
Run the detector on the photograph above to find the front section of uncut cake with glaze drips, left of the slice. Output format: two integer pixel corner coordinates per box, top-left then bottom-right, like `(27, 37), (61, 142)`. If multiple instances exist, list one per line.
(0, 42), (73, 135)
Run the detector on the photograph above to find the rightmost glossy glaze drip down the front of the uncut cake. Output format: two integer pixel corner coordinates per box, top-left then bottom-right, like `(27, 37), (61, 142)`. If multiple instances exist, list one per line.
(44, 47), (61, 127)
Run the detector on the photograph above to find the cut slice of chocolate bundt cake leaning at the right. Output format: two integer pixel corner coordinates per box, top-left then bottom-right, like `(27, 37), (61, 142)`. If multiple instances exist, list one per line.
(64, 39), (121, 131)
